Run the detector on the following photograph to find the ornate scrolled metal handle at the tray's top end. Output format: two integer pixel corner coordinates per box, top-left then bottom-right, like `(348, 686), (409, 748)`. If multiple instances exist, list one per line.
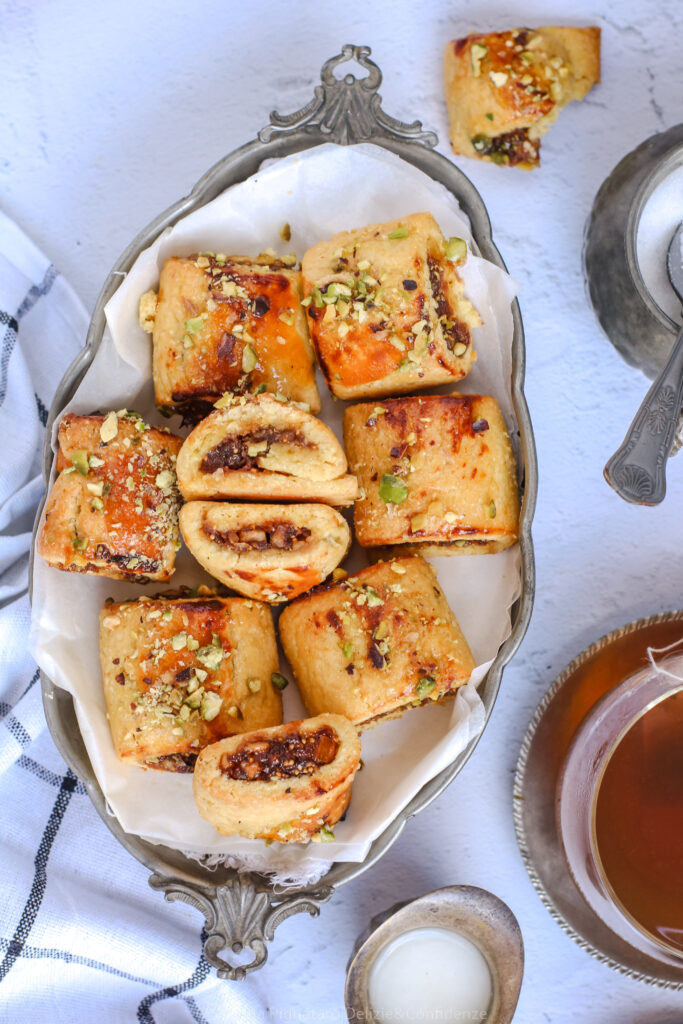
(258, 44), (437, 146)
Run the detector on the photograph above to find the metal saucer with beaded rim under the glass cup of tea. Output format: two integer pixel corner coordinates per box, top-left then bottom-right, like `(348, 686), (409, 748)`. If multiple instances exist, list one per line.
(513, 610), (683, 990)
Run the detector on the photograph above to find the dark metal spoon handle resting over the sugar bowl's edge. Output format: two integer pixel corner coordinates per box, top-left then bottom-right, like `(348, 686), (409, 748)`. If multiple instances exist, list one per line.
(603, 328), (683, 505)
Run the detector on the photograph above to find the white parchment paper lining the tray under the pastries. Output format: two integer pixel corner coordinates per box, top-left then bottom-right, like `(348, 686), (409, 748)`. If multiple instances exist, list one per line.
(31, 145), (521, 882)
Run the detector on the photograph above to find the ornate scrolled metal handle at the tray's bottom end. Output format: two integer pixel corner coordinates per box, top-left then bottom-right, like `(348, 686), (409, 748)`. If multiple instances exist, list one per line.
(150, 871), (332, 981)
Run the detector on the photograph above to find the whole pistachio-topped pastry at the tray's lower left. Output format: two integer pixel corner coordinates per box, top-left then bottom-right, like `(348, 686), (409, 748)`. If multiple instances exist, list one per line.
(99, 596), (283, 771)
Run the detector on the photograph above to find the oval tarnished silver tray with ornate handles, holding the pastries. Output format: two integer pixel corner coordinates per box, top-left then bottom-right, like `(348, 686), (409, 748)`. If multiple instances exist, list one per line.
(32, 45), (538, 980)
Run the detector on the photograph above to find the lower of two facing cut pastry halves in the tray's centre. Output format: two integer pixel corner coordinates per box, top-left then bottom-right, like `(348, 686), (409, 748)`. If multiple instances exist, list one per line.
(180, 502), (351, 604)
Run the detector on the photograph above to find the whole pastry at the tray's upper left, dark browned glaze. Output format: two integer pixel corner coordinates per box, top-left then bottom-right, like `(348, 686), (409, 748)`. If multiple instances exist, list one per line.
(139, 252), (321, 412)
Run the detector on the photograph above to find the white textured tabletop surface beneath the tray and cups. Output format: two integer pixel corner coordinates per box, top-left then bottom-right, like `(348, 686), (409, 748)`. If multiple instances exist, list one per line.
(0, 0), (683, 1024)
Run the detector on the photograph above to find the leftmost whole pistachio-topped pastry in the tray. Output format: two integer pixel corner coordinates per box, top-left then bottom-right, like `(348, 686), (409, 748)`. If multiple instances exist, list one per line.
(36, 411), (182, 582)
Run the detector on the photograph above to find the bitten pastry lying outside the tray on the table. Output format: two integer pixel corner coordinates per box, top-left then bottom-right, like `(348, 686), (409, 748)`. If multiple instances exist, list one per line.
(443, 26), (600, 170)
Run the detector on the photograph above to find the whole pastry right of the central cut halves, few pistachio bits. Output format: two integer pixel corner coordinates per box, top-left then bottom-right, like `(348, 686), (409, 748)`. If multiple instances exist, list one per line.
(344, 394), (519, 554)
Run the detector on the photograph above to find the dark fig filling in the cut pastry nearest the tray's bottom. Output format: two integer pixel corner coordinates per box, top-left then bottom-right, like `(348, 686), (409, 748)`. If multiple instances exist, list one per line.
(220, 726), (340, 782)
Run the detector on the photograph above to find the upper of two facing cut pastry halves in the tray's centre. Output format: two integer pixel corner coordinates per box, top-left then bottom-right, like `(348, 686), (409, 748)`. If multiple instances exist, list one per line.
(177, 394), (357, 505)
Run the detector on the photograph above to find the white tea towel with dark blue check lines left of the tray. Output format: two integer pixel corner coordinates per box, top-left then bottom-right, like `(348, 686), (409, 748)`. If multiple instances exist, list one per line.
(0, 213), (248, 1024)
